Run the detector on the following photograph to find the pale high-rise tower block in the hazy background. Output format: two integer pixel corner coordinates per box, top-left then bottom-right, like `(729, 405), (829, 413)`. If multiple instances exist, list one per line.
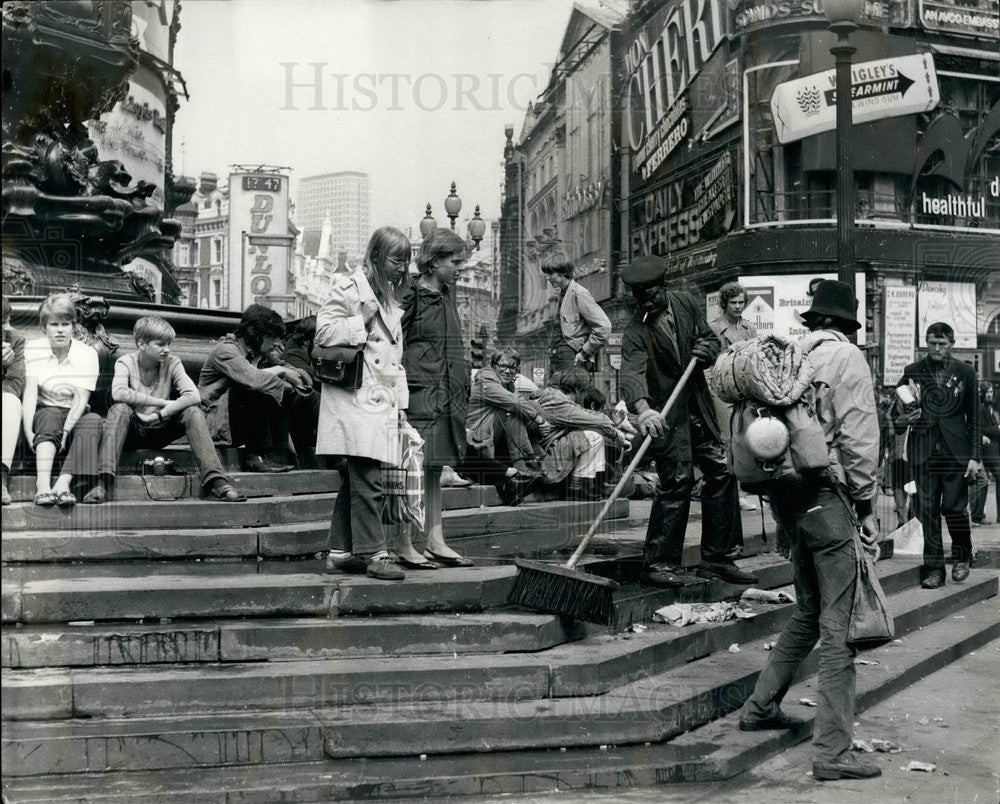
(295, 170), (371, 262)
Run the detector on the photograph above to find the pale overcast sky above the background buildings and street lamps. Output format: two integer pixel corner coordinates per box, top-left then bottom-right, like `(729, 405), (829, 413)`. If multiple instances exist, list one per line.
(174, 0), (573, 237)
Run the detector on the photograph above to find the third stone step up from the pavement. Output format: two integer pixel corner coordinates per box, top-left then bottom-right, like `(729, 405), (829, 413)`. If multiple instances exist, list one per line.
(2, 565), (932, 720)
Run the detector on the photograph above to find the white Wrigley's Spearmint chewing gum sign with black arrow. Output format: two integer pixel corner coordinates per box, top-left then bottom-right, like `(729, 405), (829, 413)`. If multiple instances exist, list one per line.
(771, 53), (941, 144)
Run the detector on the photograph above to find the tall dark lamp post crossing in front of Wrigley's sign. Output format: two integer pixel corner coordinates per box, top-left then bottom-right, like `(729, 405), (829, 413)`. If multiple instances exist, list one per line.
(823, 0), (864, 296)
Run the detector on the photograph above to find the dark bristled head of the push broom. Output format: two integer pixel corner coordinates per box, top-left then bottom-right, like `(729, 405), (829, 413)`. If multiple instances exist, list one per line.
(507, 560), (618, 625)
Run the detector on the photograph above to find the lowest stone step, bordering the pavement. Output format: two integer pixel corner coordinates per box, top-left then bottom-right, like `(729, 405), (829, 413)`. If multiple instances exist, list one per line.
(4, 600), (984, 804)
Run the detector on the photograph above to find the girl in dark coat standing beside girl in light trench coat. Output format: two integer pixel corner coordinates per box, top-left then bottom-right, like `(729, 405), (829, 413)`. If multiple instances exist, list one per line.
(397, 229), (472, 569)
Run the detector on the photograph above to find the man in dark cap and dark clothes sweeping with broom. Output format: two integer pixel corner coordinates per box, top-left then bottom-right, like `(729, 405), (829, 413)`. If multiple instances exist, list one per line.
(620, 257), (757, 587)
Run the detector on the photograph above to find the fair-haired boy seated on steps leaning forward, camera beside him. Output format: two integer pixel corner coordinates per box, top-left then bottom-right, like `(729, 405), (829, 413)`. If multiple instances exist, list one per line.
(84, 316), (246, 503)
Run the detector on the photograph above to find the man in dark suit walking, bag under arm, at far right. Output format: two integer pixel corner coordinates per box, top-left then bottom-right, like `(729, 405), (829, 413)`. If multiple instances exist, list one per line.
(895, 322), (982, 589)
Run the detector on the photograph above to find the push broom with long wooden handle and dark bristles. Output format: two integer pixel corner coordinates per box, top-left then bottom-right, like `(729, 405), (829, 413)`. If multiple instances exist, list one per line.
(507, 358), (697, 625)
